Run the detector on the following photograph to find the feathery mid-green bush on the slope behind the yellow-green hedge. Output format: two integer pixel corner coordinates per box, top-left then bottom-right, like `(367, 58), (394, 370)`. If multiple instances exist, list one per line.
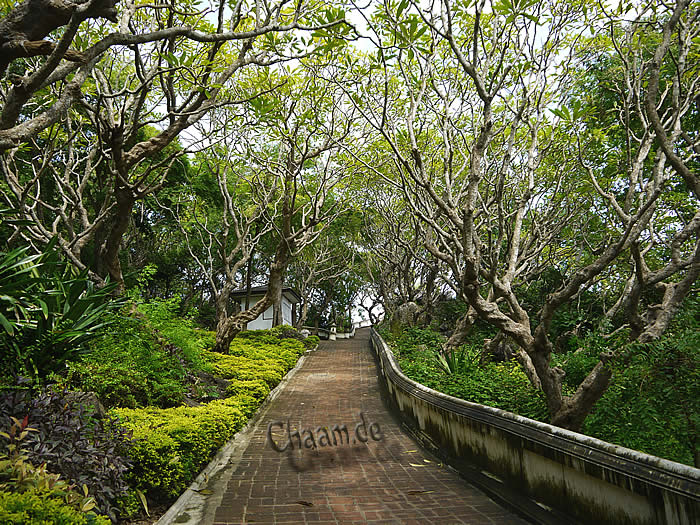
(68, 315), (188, 408)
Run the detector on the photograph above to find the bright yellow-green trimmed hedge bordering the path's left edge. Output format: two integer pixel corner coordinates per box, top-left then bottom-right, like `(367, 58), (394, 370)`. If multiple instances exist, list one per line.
(111, 330), (306, 508)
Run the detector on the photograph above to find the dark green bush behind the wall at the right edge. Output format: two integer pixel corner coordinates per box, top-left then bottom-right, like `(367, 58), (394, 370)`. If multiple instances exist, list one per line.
(583, 299), (700, 467)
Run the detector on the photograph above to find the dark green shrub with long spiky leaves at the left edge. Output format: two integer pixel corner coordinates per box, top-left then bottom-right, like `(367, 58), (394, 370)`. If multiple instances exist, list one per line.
(0, 244), (123, 381)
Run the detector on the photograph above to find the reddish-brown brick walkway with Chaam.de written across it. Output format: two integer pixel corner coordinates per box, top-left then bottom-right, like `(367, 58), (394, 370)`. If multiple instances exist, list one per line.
(196, 329), (524, 524)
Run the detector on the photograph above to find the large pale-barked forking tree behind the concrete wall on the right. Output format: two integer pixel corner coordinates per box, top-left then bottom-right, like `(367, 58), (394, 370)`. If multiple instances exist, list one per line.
(344, 0), (700, 429)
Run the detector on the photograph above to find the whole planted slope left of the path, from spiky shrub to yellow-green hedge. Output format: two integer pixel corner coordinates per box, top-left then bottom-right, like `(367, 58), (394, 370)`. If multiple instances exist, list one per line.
(0, 253), (318, 523)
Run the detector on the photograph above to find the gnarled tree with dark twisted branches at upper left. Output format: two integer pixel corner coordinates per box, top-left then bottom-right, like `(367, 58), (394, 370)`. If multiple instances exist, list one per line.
(0, 0), (348, 290)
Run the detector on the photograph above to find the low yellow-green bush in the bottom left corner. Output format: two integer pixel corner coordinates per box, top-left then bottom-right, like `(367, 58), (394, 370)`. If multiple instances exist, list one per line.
(0, 491), (111, 525)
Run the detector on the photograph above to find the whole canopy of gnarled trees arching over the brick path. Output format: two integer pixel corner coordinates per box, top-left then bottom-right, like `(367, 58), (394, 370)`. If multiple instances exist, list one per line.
(0, 0), (700, 429)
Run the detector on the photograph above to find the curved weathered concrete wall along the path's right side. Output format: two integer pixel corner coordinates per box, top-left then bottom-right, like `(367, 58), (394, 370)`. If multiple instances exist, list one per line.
(371, 329), (700, 525)
